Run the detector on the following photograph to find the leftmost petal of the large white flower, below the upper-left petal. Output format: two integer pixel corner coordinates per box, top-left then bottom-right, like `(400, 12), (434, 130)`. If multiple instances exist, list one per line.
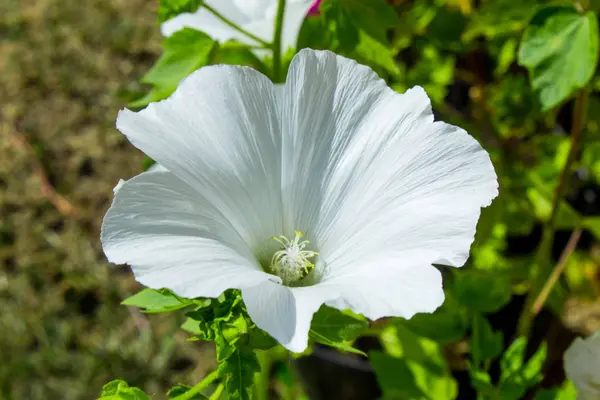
(101, 171), (277, 297)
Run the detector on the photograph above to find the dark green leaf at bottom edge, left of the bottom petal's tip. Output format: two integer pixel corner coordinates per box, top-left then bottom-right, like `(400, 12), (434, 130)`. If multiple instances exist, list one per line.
(219, 351), (260, 400)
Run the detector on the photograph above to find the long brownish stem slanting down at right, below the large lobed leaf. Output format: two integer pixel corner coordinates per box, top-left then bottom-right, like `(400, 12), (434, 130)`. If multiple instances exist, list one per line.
(517, 88), (589, 337)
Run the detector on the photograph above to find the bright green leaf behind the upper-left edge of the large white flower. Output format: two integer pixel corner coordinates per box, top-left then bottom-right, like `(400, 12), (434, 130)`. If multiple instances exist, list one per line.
(130, 28), (217, 107)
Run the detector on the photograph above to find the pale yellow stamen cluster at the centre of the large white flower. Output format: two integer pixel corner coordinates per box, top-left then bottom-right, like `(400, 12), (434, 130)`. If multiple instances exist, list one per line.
(271, 231), (319, 285)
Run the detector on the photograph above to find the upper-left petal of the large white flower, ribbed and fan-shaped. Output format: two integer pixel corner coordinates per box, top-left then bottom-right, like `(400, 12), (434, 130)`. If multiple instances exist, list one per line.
(117, 66), (282, 253)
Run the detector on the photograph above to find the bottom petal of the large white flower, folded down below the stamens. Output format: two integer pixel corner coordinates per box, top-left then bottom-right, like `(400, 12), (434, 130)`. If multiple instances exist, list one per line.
(242, 263), (444, 353)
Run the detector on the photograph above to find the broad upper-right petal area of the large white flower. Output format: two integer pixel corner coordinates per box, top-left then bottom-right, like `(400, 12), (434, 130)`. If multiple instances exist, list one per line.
(282, 50), (498, 275)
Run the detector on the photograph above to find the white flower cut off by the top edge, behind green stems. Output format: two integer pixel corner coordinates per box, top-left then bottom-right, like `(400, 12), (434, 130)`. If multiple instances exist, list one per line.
(160, 0), (315, 50)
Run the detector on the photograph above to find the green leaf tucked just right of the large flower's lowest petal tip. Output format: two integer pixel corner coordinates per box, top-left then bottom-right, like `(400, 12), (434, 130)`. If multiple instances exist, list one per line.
(309, 306), (369, 355)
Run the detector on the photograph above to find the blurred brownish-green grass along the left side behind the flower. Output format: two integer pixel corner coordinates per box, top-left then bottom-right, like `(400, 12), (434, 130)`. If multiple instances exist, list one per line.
(0, 0), (214, 400)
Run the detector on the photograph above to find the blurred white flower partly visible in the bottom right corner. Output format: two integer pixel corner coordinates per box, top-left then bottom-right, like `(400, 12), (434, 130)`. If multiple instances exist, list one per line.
(564, 331), (600, 400)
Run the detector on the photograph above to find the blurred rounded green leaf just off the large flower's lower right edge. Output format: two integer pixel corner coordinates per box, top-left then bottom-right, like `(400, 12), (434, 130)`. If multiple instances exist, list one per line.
(451, 270), (512, 313)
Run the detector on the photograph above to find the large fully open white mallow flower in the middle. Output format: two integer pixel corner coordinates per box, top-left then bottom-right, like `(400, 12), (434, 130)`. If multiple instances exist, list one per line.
(102, 50), (498, 352)
